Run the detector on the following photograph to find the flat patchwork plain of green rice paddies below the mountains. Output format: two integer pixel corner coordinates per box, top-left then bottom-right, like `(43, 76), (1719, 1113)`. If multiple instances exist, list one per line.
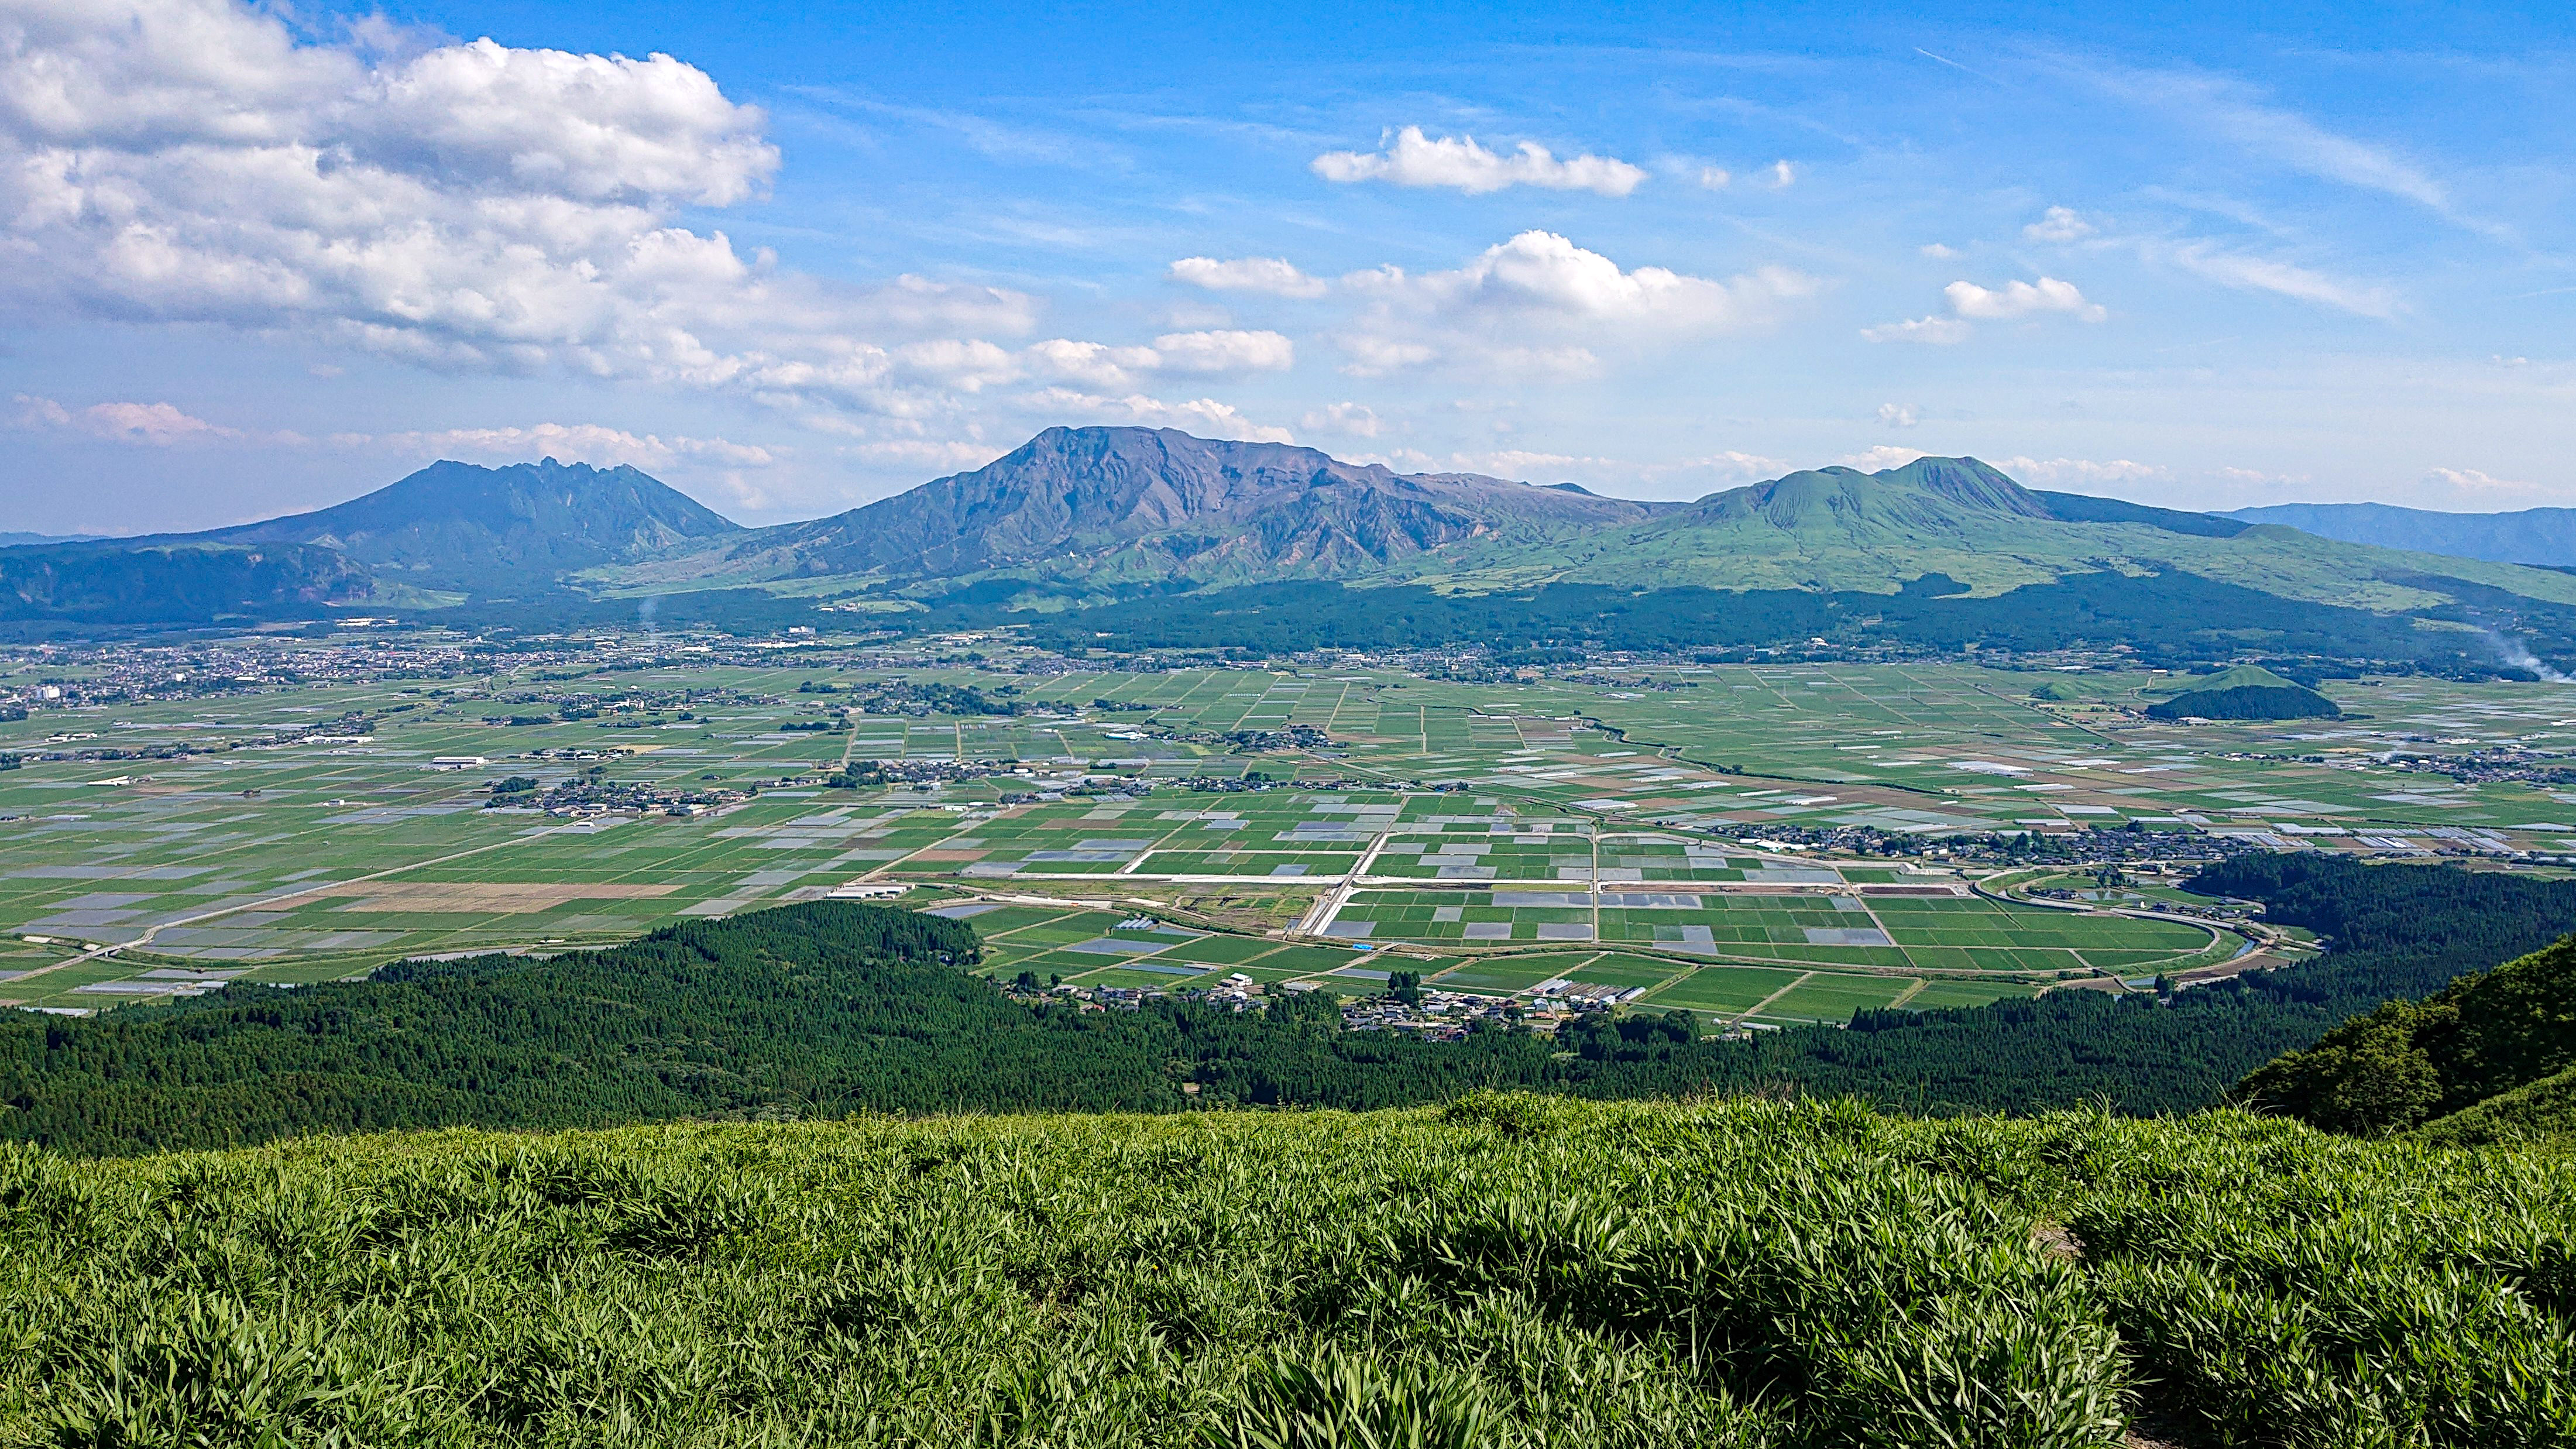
(0, 655), (2576, 1011)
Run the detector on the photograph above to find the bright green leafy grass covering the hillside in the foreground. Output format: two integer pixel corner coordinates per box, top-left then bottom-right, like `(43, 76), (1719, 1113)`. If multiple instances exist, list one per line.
(0, 1096), (2576, 1449)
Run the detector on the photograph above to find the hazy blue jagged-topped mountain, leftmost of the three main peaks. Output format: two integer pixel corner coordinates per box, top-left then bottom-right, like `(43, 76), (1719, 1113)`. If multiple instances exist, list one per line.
(172, 459), (742, 590)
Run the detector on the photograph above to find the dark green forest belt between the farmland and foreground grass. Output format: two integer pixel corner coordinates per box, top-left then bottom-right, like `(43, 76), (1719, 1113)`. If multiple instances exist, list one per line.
(0, 853), (2576, 1152)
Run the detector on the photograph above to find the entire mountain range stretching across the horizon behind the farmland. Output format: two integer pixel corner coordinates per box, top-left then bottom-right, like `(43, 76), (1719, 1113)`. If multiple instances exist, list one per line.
(15, 428), (2576, 657)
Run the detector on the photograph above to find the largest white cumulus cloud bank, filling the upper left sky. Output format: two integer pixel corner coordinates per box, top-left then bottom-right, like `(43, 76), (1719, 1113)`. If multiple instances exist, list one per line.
(0, 0), (1226, 436)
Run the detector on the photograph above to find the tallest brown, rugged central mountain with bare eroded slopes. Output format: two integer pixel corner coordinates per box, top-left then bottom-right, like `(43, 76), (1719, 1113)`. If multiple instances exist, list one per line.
(634, 428), (1672, 580)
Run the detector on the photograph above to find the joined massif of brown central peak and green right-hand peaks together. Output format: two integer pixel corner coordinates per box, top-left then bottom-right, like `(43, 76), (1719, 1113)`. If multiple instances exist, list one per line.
(588, 428), (2576, 631)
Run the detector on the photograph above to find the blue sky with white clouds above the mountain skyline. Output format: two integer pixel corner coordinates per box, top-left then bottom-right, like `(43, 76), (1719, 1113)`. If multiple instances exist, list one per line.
(0, 0), (2576, 531)
